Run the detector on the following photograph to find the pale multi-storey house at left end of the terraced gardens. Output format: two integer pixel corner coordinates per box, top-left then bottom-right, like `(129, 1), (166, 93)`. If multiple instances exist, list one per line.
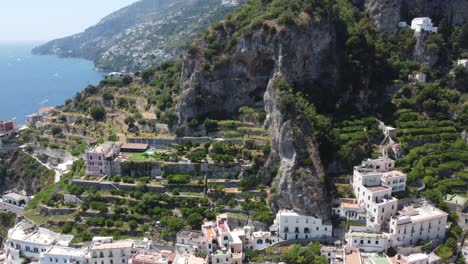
(85, 142), (123, 176)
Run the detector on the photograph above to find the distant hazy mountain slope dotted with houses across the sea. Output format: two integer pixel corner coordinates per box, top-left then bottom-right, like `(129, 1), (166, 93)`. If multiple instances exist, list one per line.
(33, 0), (244, 71)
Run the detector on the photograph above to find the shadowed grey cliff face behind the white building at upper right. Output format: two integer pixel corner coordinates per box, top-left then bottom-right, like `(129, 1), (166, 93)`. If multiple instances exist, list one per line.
(365, 0), (468, 32)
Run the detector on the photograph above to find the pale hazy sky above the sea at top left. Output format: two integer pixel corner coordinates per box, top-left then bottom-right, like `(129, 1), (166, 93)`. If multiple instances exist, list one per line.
(0, 0), (137, 40)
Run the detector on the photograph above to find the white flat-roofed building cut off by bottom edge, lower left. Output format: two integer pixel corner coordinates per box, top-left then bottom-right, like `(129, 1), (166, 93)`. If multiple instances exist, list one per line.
(39, 246), (87, 264)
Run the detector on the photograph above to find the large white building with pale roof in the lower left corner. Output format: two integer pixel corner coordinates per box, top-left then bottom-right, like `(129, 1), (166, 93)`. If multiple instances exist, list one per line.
(5, 221), (73, 264)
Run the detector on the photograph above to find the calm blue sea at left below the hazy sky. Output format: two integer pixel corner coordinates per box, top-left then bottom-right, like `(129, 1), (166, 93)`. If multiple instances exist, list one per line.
(0, 42), (105, 124)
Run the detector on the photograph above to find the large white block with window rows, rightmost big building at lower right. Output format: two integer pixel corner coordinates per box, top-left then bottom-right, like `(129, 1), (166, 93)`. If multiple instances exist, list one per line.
(390, 205), (448, 246)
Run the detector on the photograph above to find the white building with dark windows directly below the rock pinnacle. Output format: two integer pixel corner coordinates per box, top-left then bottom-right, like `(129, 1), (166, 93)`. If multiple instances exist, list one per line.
(271, 209), (333, 240)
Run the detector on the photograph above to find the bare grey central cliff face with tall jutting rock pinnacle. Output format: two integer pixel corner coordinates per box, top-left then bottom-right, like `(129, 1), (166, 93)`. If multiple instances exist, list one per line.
(177, 19), (338, 219)
